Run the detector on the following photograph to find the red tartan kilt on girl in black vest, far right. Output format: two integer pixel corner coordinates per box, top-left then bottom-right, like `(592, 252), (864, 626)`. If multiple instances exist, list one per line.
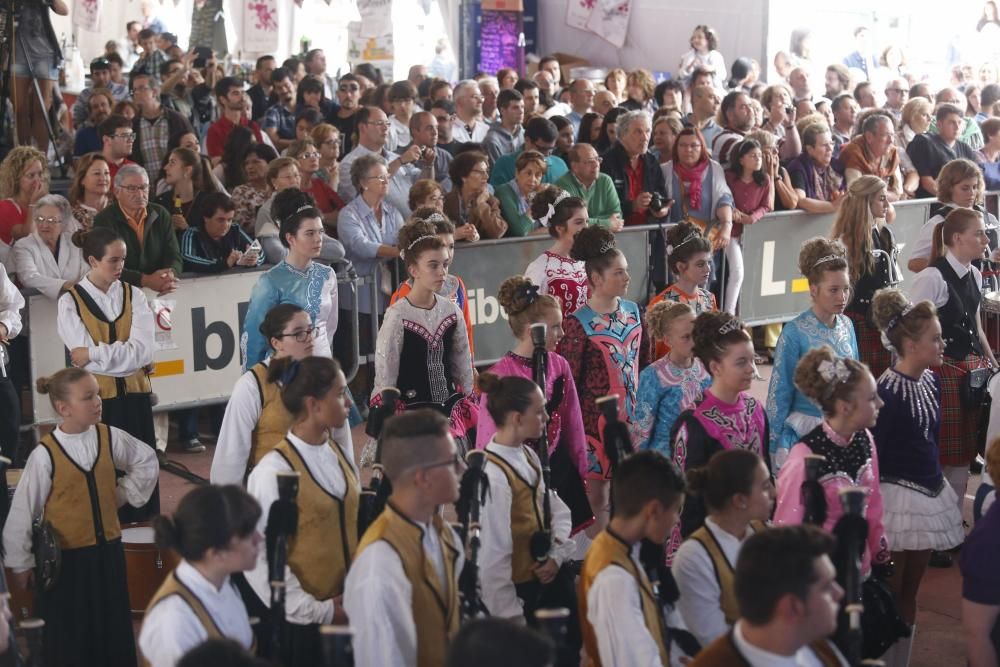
(931, 354), (986, 466)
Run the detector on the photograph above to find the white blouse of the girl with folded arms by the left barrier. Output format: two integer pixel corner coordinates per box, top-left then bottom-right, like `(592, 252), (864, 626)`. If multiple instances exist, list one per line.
(56, 277), (154, 377)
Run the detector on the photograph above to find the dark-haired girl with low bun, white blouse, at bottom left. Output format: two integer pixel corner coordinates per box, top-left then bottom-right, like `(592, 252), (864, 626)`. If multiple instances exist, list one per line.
(139, 485), (264, 667)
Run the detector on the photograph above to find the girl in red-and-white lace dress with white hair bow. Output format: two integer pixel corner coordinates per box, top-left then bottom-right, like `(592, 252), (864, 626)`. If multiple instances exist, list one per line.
(524, 185), (590, 317)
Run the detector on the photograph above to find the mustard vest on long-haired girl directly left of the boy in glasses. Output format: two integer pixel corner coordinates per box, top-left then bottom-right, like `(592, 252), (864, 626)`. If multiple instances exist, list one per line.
(274, 439), (361, 600)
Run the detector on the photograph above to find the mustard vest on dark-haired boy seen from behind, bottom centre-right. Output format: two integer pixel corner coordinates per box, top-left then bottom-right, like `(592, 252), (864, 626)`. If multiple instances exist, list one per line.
(577, 529), (670, 667)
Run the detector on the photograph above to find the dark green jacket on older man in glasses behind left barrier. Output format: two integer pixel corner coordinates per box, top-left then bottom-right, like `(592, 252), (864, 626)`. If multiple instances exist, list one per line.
(94, 201), (184, 287)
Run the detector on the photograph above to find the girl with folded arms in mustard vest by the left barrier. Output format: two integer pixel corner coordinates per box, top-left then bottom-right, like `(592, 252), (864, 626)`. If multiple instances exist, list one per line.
(57, 227), (160, 523)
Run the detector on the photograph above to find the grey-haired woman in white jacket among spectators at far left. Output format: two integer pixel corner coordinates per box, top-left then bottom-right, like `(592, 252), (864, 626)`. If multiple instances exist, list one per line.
(14, 195), (90, 301)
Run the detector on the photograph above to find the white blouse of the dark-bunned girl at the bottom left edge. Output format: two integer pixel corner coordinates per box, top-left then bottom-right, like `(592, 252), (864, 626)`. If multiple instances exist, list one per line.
(139, 560), (253, 667)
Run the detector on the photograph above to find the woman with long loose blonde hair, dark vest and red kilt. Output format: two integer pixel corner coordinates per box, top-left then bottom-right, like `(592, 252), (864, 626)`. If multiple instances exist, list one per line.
(830, 176), (899, 377)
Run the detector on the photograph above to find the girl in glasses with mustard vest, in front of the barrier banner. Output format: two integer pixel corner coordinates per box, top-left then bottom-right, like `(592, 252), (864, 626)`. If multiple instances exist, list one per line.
(211, 303), (316, 484)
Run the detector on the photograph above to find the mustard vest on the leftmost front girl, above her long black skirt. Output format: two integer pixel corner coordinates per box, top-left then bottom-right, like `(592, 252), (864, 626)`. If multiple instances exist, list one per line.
(39, 424), (122, 549)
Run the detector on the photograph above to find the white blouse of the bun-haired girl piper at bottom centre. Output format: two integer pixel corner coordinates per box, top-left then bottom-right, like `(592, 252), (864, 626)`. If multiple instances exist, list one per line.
(479, 440), (576, 621)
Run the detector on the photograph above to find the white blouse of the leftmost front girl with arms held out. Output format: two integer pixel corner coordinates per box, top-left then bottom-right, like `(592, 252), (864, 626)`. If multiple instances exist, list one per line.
(3, 426), (160, 572)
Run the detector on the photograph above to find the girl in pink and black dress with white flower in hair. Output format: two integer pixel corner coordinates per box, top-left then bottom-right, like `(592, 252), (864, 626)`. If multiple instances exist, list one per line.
(774, 346), (890, 574)
